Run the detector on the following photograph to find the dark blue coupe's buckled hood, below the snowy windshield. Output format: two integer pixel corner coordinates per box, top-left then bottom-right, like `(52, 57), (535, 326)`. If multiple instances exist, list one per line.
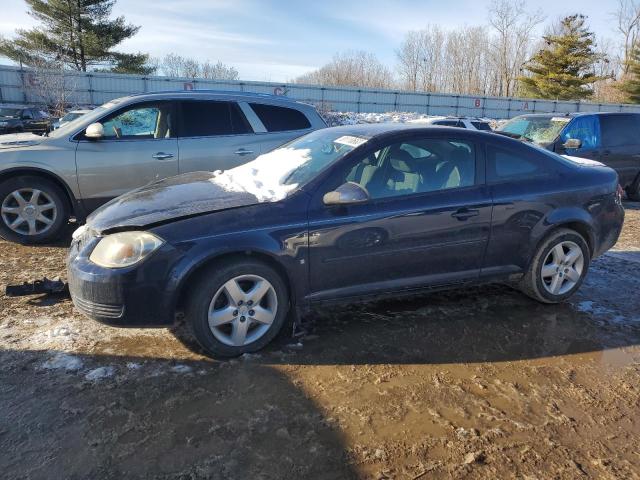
(87, 172), (261, 234)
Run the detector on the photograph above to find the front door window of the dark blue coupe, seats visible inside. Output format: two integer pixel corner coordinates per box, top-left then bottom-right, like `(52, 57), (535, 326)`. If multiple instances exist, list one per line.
(345, 138), (476, 199)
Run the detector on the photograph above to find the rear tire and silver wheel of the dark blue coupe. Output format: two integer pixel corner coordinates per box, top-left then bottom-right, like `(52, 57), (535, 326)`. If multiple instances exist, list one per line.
(519, 228), (591, 303)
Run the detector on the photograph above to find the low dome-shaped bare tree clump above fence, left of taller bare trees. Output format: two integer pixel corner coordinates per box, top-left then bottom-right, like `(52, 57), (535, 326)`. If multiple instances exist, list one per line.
(295, 51), (393, 88)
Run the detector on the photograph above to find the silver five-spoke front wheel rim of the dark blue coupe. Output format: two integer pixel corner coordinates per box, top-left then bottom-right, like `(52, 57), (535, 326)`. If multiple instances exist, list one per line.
(208, 275), (278, 347)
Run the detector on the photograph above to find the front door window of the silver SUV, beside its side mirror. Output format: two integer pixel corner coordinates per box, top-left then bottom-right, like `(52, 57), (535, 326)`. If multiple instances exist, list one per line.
(102, 102), (174, 140)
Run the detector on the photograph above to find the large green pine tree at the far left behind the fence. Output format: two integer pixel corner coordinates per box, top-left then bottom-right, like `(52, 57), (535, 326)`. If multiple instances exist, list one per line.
(0, 0), (149, 74)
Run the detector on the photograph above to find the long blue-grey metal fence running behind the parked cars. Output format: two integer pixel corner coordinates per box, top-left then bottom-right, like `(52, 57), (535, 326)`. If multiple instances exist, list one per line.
(0, 65), (640, 118)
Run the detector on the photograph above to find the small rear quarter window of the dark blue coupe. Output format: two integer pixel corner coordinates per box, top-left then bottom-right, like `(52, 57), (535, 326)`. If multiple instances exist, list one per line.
(487, 145), (549, 182)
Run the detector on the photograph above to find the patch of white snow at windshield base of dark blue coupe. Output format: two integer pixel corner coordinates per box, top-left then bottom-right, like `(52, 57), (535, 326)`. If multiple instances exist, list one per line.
(211, 147), (311, 202)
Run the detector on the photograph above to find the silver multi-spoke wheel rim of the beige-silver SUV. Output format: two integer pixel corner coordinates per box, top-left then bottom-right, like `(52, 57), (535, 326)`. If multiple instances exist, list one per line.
(0, 188), (58, 235)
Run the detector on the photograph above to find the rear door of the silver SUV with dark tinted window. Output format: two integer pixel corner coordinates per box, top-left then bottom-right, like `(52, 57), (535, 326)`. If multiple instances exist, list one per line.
(178, 100), (260, 173)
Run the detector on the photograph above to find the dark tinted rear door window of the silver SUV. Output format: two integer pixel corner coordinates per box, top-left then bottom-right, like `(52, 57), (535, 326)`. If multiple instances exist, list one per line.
(180, 100), (251, 137)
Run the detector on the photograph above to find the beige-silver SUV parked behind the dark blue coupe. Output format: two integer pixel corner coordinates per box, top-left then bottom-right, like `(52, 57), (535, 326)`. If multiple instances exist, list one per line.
(0, 90), (326, 243)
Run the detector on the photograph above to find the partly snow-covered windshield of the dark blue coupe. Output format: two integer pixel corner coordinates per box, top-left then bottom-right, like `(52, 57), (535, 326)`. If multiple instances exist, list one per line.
(212, 129), (368, 202)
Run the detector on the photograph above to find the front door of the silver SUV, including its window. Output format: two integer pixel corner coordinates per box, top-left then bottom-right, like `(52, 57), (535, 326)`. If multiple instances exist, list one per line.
(75, 101), (178, 210)
